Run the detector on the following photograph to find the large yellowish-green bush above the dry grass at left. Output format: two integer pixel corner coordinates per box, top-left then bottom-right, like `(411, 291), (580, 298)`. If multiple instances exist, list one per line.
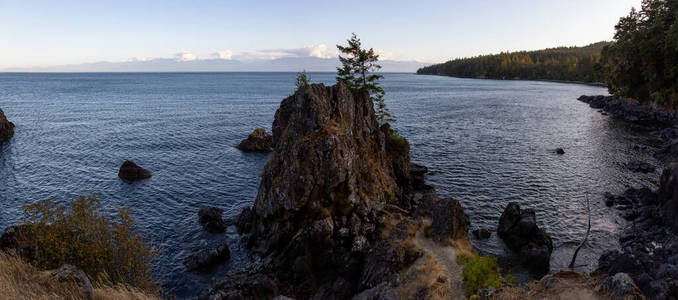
(23, 194), (159, 293)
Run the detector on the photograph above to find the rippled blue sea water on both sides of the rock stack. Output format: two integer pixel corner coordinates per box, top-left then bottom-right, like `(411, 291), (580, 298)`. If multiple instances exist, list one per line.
(0, 73), (656, 298)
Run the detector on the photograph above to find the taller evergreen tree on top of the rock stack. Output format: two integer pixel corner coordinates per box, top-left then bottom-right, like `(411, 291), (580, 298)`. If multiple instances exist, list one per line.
(337, 33), (395, 124)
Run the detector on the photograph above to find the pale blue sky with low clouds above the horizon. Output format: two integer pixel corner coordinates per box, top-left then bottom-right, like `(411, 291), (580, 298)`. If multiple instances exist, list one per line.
(0, 0), (641, 70)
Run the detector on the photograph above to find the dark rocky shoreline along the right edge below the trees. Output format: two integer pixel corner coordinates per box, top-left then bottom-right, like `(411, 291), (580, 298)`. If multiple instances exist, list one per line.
(579, 96), (678, 299)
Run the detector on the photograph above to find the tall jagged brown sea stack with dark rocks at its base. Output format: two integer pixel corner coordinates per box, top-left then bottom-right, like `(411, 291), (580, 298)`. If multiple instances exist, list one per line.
(201, 84), (467, 299)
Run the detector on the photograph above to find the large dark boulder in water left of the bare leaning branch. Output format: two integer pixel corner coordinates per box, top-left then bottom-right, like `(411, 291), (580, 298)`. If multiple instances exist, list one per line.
(497, 202), (553, 276)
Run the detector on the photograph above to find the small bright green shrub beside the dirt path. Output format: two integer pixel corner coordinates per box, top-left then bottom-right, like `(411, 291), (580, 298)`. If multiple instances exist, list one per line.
(457, 254), (504, 295)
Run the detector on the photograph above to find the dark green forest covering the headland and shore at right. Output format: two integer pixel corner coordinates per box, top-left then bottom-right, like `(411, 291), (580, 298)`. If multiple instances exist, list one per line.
(417, 0), (678, 108)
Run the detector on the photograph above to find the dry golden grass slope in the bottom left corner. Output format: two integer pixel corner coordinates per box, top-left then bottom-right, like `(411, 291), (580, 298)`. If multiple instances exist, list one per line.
(0, 253), (158, 300)
